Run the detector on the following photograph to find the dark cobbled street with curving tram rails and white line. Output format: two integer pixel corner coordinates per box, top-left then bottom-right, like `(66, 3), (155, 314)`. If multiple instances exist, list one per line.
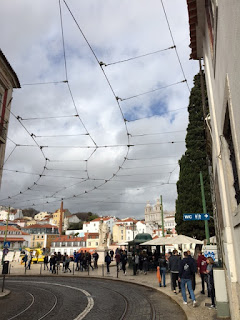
(0, 277), (185, 320)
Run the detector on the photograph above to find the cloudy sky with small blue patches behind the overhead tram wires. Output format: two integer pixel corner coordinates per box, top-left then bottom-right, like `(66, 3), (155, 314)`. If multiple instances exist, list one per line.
(0, 0), (198, 219)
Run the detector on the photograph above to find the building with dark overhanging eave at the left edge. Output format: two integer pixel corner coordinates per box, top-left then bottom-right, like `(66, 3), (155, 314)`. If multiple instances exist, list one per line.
(0, 50), (20, 186)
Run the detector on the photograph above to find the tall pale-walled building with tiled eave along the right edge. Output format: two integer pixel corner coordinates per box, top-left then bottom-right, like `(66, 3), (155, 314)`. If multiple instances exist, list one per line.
(188, 0), (240, 320)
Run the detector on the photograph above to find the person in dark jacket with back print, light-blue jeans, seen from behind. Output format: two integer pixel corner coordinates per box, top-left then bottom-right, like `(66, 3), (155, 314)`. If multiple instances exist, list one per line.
(179, 251), (196, 307)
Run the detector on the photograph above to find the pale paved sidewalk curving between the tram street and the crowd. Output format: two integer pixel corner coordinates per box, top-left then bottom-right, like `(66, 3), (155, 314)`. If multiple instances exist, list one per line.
(0, 262), (217, 320)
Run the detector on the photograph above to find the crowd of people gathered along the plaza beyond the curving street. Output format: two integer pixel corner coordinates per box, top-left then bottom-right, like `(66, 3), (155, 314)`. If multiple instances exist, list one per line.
(23, 248), (215, 308)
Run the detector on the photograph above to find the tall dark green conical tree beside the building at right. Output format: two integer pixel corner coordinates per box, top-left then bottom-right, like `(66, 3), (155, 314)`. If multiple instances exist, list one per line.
(176, 74), (215, 240)
